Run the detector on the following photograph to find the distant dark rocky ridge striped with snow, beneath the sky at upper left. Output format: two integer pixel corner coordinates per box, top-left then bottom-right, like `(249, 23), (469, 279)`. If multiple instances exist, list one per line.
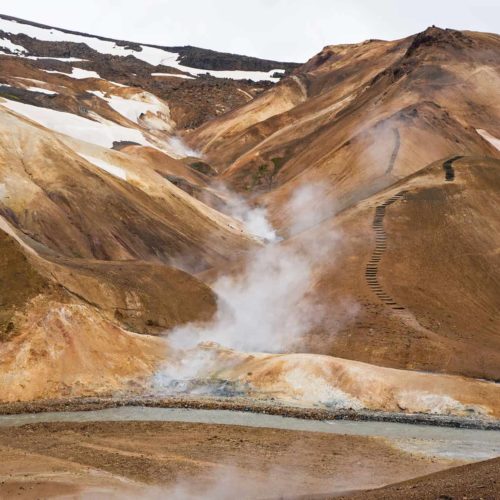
(0, 14), (297, 128)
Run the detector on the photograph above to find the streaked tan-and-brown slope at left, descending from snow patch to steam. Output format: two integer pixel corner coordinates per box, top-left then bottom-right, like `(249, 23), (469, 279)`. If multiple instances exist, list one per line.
(0, 103), (256, 269)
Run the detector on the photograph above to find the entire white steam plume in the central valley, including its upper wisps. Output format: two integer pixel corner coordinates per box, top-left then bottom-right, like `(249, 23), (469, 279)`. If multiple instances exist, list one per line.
(156, 185), (346, 388)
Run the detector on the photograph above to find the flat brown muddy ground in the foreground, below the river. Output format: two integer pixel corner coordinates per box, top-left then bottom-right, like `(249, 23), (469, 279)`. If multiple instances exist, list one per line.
(0, 422), (460, 499)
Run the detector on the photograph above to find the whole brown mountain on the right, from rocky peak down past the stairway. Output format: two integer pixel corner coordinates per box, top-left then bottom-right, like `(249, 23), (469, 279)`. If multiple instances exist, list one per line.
(186, 27), (500, 380)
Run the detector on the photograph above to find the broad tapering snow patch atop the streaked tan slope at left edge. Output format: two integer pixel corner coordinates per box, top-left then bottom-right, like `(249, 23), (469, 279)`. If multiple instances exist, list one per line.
(1, 100), (151, 148)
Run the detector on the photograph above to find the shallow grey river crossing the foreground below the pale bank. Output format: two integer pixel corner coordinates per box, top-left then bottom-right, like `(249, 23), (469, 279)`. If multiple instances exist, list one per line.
(0, 406), (500, 461)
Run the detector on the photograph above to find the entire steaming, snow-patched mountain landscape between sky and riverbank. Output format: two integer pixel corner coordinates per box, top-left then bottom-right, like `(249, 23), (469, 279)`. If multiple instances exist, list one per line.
(0, 16), (500, 418)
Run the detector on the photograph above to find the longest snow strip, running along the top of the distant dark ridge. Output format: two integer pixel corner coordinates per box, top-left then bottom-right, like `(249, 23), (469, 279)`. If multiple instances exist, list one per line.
(0, 19), (284, 81)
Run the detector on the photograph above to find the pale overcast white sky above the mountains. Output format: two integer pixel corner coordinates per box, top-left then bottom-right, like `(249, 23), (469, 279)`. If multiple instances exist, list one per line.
(0, 0), (500, 62)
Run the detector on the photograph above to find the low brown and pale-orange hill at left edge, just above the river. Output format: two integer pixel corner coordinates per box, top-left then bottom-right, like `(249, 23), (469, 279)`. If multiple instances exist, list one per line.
(0, 212), (219, 401)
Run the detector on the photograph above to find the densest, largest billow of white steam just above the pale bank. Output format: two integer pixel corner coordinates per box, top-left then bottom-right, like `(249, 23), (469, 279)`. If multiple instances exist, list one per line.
(169, 245), (321, 352)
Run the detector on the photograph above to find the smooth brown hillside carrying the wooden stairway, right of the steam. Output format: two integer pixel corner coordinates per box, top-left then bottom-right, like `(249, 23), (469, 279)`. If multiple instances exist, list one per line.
(295, 157), (500, 380)
